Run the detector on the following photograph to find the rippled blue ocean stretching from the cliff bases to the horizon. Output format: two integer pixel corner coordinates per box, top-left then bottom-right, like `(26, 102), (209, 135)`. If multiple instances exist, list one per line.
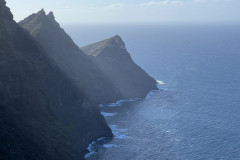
(64, 24), (240, 160)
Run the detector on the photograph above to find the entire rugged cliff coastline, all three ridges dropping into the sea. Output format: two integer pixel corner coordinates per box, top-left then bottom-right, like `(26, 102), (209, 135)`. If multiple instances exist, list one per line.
(0, 0), (157, 160)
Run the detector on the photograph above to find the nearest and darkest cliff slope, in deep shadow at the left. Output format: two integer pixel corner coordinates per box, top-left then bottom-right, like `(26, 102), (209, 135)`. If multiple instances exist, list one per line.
(0, 0), (112, 160)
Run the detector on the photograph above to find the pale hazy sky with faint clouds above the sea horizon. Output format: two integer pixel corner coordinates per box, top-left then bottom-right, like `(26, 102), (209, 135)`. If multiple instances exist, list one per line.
(6, 0), (240, 23)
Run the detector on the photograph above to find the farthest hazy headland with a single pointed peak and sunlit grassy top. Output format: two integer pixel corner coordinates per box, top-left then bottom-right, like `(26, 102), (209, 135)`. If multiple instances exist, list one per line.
(81, 35), (157, 98)
